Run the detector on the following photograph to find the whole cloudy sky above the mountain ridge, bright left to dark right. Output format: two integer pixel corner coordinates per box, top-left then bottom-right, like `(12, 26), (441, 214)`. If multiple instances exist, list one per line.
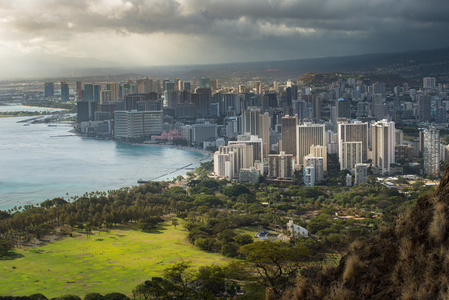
(0, 0), (449, 77)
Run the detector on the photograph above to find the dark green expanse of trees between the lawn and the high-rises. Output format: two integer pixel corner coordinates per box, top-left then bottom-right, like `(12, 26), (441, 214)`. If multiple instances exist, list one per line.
(0, 162), (424, 299)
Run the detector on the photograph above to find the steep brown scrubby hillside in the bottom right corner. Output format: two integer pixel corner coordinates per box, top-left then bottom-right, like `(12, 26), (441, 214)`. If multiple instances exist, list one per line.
(284, 169), (449, 299)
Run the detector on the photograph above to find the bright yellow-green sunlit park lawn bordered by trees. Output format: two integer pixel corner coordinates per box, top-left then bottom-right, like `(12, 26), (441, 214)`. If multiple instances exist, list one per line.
(0, 222), (230, 298)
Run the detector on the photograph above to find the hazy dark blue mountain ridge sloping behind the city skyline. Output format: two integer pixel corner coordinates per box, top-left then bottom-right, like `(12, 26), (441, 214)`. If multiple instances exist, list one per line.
(13, 47), (449, 83)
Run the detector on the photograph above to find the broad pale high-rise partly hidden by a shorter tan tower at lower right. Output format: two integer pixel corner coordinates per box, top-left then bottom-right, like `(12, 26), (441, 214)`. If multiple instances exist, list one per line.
(296, 123), (326, 165)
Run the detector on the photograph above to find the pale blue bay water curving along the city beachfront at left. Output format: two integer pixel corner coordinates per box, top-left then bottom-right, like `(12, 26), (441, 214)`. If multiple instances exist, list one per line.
(0, 106), (205, 210)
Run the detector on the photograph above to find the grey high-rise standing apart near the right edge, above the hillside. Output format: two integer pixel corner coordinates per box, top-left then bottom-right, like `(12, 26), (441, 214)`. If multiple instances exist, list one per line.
(424, 127), (441, 177)
